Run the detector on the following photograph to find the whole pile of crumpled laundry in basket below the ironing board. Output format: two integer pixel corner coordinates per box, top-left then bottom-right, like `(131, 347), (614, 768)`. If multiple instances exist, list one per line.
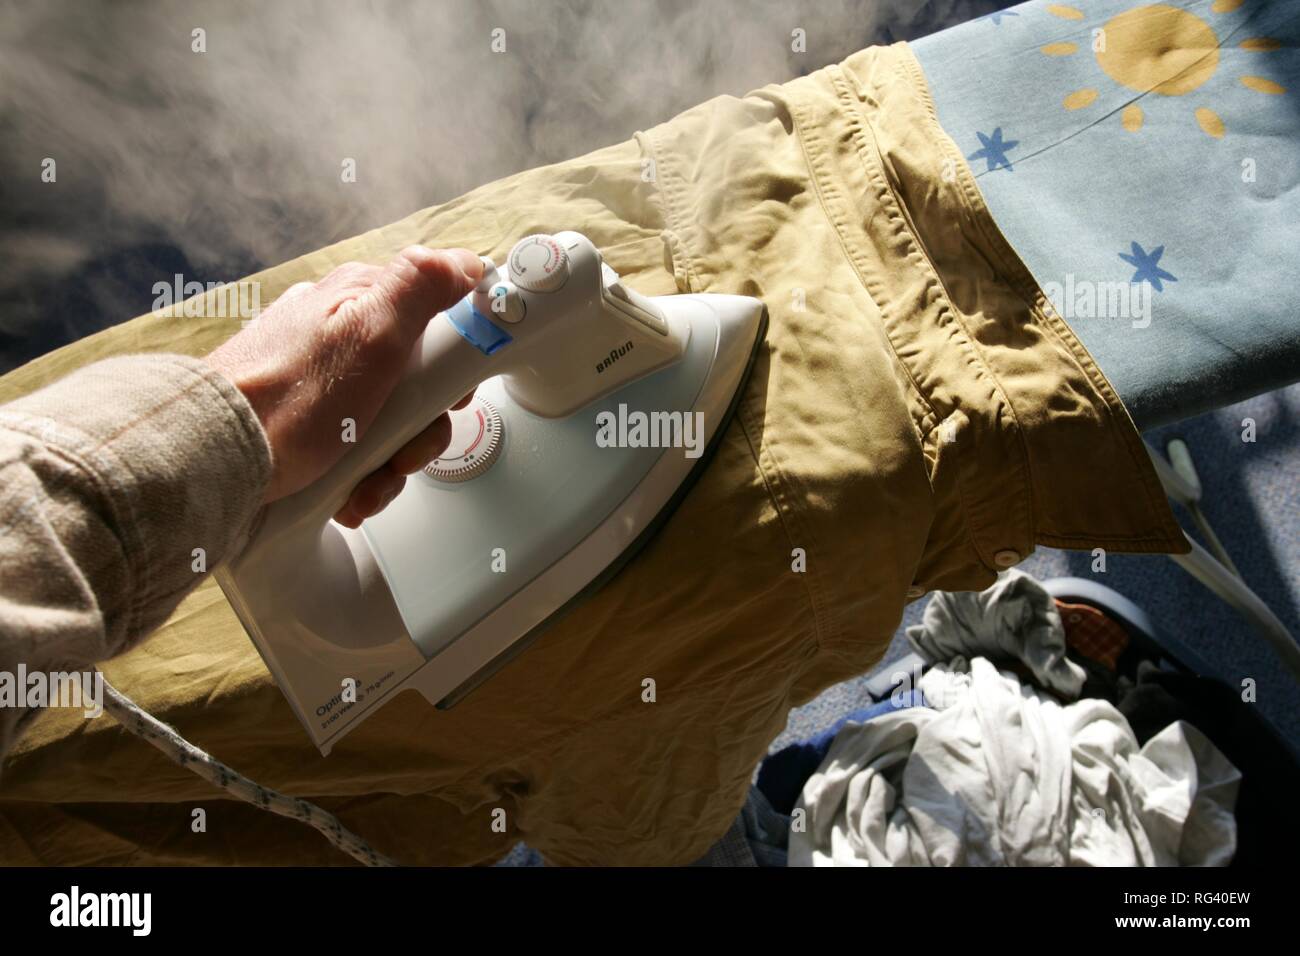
(710, 570), (1297, 866)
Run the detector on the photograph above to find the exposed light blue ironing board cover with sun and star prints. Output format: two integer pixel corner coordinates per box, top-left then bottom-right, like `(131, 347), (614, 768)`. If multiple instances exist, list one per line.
(911, 0), (1300, 428)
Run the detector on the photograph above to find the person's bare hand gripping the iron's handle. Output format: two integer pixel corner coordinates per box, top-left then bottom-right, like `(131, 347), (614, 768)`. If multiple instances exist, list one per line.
(207, 246), (482, 528)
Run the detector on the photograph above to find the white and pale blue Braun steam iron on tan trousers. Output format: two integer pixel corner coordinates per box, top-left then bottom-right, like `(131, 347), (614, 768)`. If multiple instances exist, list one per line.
(208, 232), (767, 754)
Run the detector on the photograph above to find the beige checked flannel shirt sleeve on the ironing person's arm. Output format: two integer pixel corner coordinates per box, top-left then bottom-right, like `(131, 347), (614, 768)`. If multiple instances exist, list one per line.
(0, 355), (270, 756)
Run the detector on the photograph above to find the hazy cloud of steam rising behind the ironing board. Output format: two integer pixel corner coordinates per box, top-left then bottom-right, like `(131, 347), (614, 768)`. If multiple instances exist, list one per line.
(0, 0), (1004, 371)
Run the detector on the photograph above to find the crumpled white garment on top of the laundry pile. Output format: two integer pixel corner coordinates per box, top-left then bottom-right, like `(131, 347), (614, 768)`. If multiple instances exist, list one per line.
(789, 582), (1242, 866)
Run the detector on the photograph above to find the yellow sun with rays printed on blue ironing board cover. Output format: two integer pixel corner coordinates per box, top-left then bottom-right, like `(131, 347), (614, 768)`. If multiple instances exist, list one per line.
(1040, 0), (1286, 139)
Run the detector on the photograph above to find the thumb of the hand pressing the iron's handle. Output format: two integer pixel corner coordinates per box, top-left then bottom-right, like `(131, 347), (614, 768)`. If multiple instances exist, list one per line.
(376, 246), (484, 343)
